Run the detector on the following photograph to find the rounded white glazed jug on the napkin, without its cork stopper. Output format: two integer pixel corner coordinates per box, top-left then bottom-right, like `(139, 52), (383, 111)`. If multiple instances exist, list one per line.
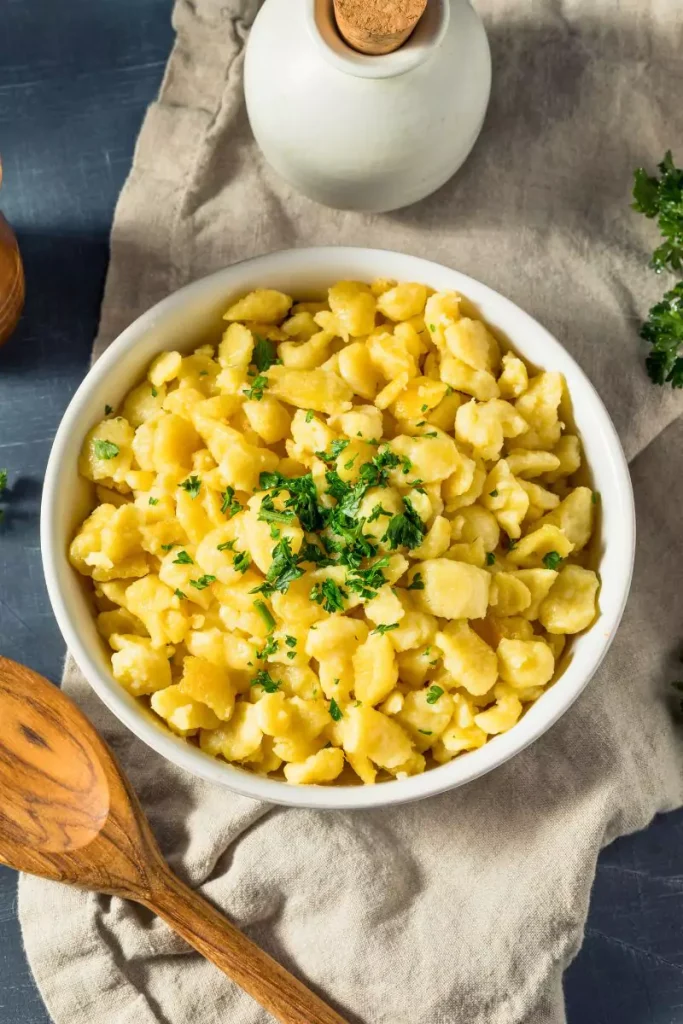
(245, 0), (490, 213)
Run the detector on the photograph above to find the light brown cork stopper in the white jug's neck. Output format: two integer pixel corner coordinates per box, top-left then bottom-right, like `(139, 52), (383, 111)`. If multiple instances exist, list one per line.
(334, 0), (427, 56)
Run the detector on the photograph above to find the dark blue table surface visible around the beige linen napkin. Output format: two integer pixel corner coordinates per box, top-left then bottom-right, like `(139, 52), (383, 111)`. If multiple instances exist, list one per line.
(0, 0), (683, 1024)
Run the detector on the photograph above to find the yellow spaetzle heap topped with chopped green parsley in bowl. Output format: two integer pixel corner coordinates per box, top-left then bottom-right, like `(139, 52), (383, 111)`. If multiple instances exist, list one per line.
(70, 281), (599, 783)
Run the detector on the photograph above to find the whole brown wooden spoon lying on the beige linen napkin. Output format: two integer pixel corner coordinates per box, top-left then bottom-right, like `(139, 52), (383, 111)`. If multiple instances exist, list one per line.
(0, 657), (345, 1024)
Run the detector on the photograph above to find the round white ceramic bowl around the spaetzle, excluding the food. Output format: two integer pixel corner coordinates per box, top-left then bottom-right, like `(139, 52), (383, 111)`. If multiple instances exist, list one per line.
(41, 247), (635, 808)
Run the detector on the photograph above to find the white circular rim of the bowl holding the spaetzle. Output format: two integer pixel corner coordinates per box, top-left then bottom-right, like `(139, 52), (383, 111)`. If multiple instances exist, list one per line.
(40, 246), (635, 810)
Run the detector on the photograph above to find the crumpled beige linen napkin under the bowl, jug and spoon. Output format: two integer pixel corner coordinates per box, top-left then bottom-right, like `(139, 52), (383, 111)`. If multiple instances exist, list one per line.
(19, 0), (683, 1024)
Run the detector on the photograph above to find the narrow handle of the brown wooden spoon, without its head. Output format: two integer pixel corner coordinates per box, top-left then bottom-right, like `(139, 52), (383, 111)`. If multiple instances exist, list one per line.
(141, 870), (347, 1024)
